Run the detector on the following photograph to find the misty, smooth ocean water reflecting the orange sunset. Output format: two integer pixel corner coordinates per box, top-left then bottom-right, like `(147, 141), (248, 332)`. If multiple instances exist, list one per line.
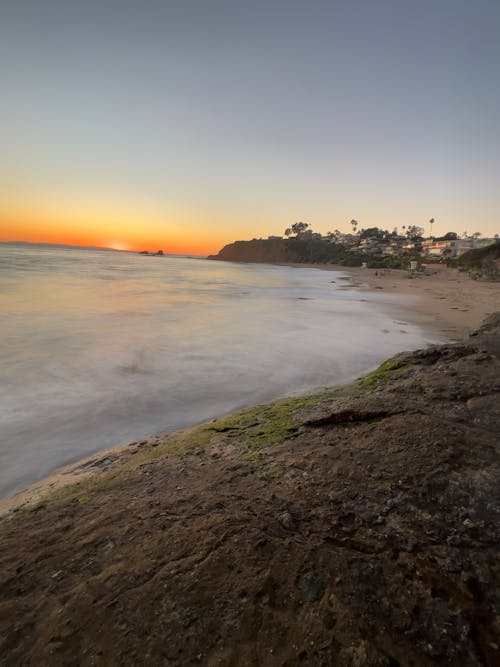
(0, 244), (433, 497)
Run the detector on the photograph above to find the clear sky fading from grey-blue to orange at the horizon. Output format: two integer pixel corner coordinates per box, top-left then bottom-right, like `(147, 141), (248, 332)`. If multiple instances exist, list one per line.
(0, 0), (500, 254)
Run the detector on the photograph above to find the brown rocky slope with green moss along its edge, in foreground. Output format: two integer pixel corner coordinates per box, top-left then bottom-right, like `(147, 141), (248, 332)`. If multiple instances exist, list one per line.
(0, 314), (500, 667)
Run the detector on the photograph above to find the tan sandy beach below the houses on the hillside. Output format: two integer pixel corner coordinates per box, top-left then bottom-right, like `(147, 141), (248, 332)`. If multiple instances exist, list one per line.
(293, 264), (500, 341)
